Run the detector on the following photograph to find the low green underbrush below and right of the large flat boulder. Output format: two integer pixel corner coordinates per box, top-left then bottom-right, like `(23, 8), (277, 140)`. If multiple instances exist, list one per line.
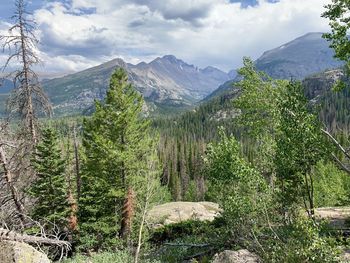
(150, 216), (344, 263)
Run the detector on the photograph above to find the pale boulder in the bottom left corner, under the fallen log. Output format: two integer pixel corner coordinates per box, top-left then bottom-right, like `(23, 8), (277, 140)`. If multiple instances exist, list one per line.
(0, 241), (51, 263)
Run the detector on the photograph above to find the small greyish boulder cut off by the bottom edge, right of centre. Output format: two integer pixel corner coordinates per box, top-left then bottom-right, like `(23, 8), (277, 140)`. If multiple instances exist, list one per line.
(213, 249), (260, 263)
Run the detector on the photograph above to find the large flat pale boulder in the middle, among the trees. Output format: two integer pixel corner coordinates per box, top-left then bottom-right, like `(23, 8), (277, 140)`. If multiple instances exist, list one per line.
(148, 202), (221, 227)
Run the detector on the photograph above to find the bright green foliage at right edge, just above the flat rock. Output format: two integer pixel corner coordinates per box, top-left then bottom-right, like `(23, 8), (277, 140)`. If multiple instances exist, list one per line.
(312, 162), (350, 207)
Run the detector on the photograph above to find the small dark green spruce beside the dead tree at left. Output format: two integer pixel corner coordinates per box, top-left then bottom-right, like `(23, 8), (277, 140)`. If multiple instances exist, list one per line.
(28, 128), (69, 227)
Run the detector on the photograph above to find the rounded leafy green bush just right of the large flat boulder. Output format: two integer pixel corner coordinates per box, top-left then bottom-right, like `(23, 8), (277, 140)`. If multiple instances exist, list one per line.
(205, 131), (272, 245)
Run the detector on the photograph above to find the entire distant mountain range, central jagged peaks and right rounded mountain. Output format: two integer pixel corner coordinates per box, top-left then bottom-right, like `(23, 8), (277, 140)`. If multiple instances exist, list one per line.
(0, 33), (341, 116)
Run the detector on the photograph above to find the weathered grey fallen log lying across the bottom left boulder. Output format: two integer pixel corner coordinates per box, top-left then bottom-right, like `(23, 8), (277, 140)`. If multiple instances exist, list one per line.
(0, 228), (71, 250)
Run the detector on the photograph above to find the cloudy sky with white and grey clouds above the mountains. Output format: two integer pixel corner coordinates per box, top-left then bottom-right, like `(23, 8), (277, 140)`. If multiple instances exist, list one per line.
(0, 0), (329, 72)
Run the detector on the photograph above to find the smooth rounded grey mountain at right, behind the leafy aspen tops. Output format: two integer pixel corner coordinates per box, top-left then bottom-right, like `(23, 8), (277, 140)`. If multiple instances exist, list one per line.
(205, 33), (342, 100)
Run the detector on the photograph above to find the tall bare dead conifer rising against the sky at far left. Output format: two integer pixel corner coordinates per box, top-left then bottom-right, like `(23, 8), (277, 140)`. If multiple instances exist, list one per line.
(0, 0), (51, 144)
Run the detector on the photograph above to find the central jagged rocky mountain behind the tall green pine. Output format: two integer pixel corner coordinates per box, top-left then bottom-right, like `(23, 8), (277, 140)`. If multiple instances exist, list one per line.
(43, 55), (230, 114)
